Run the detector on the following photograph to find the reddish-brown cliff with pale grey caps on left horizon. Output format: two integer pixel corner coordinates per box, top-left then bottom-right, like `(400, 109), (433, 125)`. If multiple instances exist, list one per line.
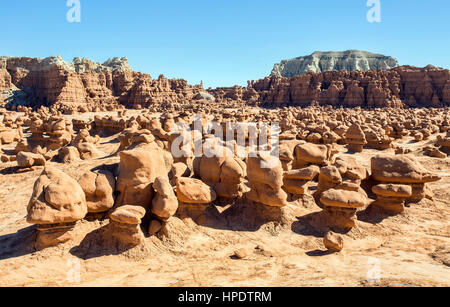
(0, 57), (203, 112)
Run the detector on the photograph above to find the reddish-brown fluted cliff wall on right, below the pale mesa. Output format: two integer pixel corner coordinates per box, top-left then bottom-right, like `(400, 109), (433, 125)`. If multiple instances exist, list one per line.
(210, 66), (450, 107)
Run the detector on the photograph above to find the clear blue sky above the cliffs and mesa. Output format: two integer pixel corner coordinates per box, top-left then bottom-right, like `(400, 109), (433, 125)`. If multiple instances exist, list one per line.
(0, 0), (450, 87)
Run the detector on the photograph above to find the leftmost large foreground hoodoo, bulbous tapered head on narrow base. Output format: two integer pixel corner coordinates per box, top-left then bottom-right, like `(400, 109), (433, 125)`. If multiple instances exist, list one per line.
(27, 166), (87, 249)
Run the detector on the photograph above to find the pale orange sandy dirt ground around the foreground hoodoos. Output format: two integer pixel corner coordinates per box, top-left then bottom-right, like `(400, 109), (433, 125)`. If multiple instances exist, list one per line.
(0, 113), (450, 287)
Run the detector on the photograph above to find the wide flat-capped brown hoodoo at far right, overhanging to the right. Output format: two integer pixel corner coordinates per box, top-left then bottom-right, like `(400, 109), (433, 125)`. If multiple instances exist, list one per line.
(371, 155), (441, 203)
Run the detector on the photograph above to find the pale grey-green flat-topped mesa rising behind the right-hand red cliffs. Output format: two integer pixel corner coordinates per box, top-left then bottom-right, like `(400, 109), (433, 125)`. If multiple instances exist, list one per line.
(271, 50), (399, 77)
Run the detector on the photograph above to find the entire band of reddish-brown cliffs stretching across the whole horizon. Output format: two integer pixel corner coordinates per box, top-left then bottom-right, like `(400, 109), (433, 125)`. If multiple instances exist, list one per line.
(0, 57), (450, 113)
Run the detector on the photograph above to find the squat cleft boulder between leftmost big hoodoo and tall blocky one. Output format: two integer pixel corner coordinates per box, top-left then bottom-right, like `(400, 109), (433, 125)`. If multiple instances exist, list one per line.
(78, 170), (116, 213)
